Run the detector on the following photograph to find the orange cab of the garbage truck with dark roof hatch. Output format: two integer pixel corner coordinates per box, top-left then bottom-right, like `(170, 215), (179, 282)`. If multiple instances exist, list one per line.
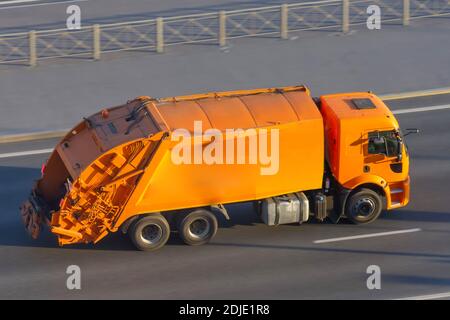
(320, 92), (409, 223)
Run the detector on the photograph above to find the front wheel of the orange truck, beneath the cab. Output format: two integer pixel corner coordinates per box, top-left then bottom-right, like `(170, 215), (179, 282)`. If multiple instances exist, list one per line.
(346, 189), (382, 224)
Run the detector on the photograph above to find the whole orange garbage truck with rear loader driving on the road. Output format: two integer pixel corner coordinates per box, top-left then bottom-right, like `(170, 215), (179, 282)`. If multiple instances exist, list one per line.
(20, 86), (410, 251)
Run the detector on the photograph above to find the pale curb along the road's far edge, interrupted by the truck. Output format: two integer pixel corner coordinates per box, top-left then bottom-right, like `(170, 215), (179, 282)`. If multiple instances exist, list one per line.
(0, 87), (450, 144)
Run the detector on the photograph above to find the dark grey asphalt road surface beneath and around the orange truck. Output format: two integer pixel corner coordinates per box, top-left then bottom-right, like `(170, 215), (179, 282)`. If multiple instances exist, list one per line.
(0, 95), (450, 299)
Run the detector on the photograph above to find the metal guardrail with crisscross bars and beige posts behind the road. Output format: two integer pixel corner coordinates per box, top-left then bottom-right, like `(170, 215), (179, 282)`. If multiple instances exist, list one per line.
(0, 0), (450, 66)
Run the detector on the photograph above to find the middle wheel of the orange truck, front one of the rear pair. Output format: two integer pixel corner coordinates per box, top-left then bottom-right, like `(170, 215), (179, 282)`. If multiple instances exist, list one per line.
(178, 209), (218, 246)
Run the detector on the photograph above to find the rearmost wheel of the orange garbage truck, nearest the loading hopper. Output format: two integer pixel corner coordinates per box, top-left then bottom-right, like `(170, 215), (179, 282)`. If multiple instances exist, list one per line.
(132, 214), (170, 251)
